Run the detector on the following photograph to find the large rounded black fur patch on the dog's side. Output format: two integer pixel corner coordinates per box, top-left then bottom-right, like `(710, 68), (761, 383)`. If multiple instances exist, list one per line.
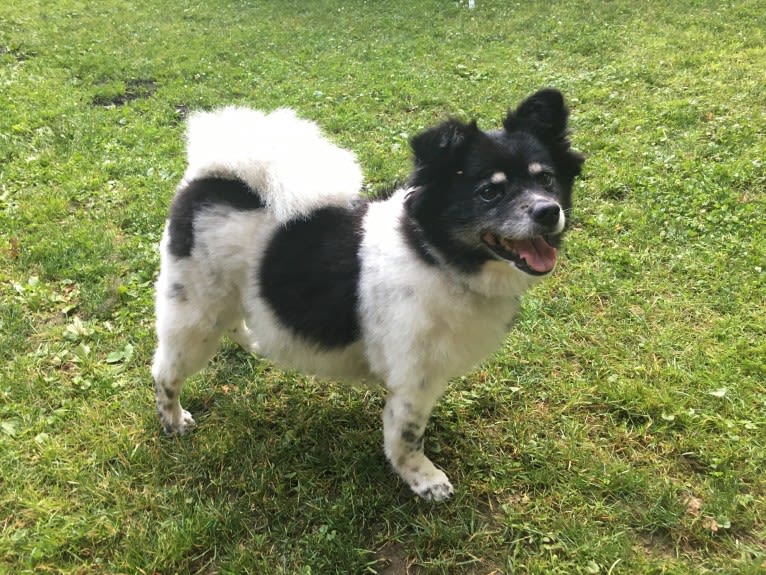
(259, 203), (367, 349)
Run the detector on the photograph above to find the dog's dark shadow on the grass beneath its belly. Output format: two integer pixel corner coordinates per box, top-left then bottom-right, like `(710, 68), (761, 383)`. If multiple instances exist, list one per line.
(155, 354), (404, 502)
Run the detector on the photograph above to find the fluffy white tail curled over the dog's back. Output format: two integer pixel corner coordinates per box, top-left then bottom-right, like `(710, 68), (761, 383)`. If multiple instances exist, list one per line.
(184, 106), (362, 222)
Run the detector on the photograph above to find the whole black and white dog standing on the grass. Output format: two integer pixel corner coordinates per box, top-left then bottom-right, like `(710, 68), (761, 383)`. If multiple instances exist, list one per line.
(152, 89), (583, 500)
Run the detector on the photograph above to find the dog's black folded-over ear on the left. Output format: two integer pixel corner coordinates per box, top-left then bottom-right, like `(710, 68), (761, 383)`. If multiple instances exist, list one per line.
(410, 119), (479, 175)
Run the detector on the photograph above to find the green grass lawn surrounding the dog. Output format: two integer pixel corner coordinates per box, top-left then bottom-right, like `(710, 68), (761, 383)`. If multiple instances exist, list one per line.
(0, 0), (766, 575)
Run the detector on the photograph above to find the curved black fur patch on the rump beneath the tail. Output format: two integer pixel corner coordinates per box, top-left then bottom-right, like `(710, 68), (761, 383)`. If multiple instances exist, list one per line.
(169, 178), (264, 258)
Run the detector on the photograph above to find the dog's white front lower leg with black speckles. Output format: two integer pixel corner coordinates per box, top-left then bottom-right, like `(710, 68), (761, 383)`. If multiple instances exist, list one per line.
(383, 389), (453, 501)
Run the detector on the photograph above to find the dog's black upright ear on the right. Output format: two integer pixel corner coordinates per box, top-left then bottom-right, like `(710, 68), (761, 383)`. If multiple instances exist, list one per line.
(503, 88), (585, 178)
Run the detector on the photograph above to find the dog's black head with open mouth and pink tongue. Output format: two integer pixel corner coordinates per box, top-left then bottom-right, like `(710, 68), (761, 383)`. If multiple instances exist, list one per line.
(406, 89), (584, 276)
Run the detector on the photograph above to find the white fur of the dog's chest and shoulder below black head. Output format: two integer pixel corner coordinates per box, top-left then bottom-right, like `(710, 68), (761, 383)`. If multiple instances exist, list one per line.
(360, 191), (533, 387)
